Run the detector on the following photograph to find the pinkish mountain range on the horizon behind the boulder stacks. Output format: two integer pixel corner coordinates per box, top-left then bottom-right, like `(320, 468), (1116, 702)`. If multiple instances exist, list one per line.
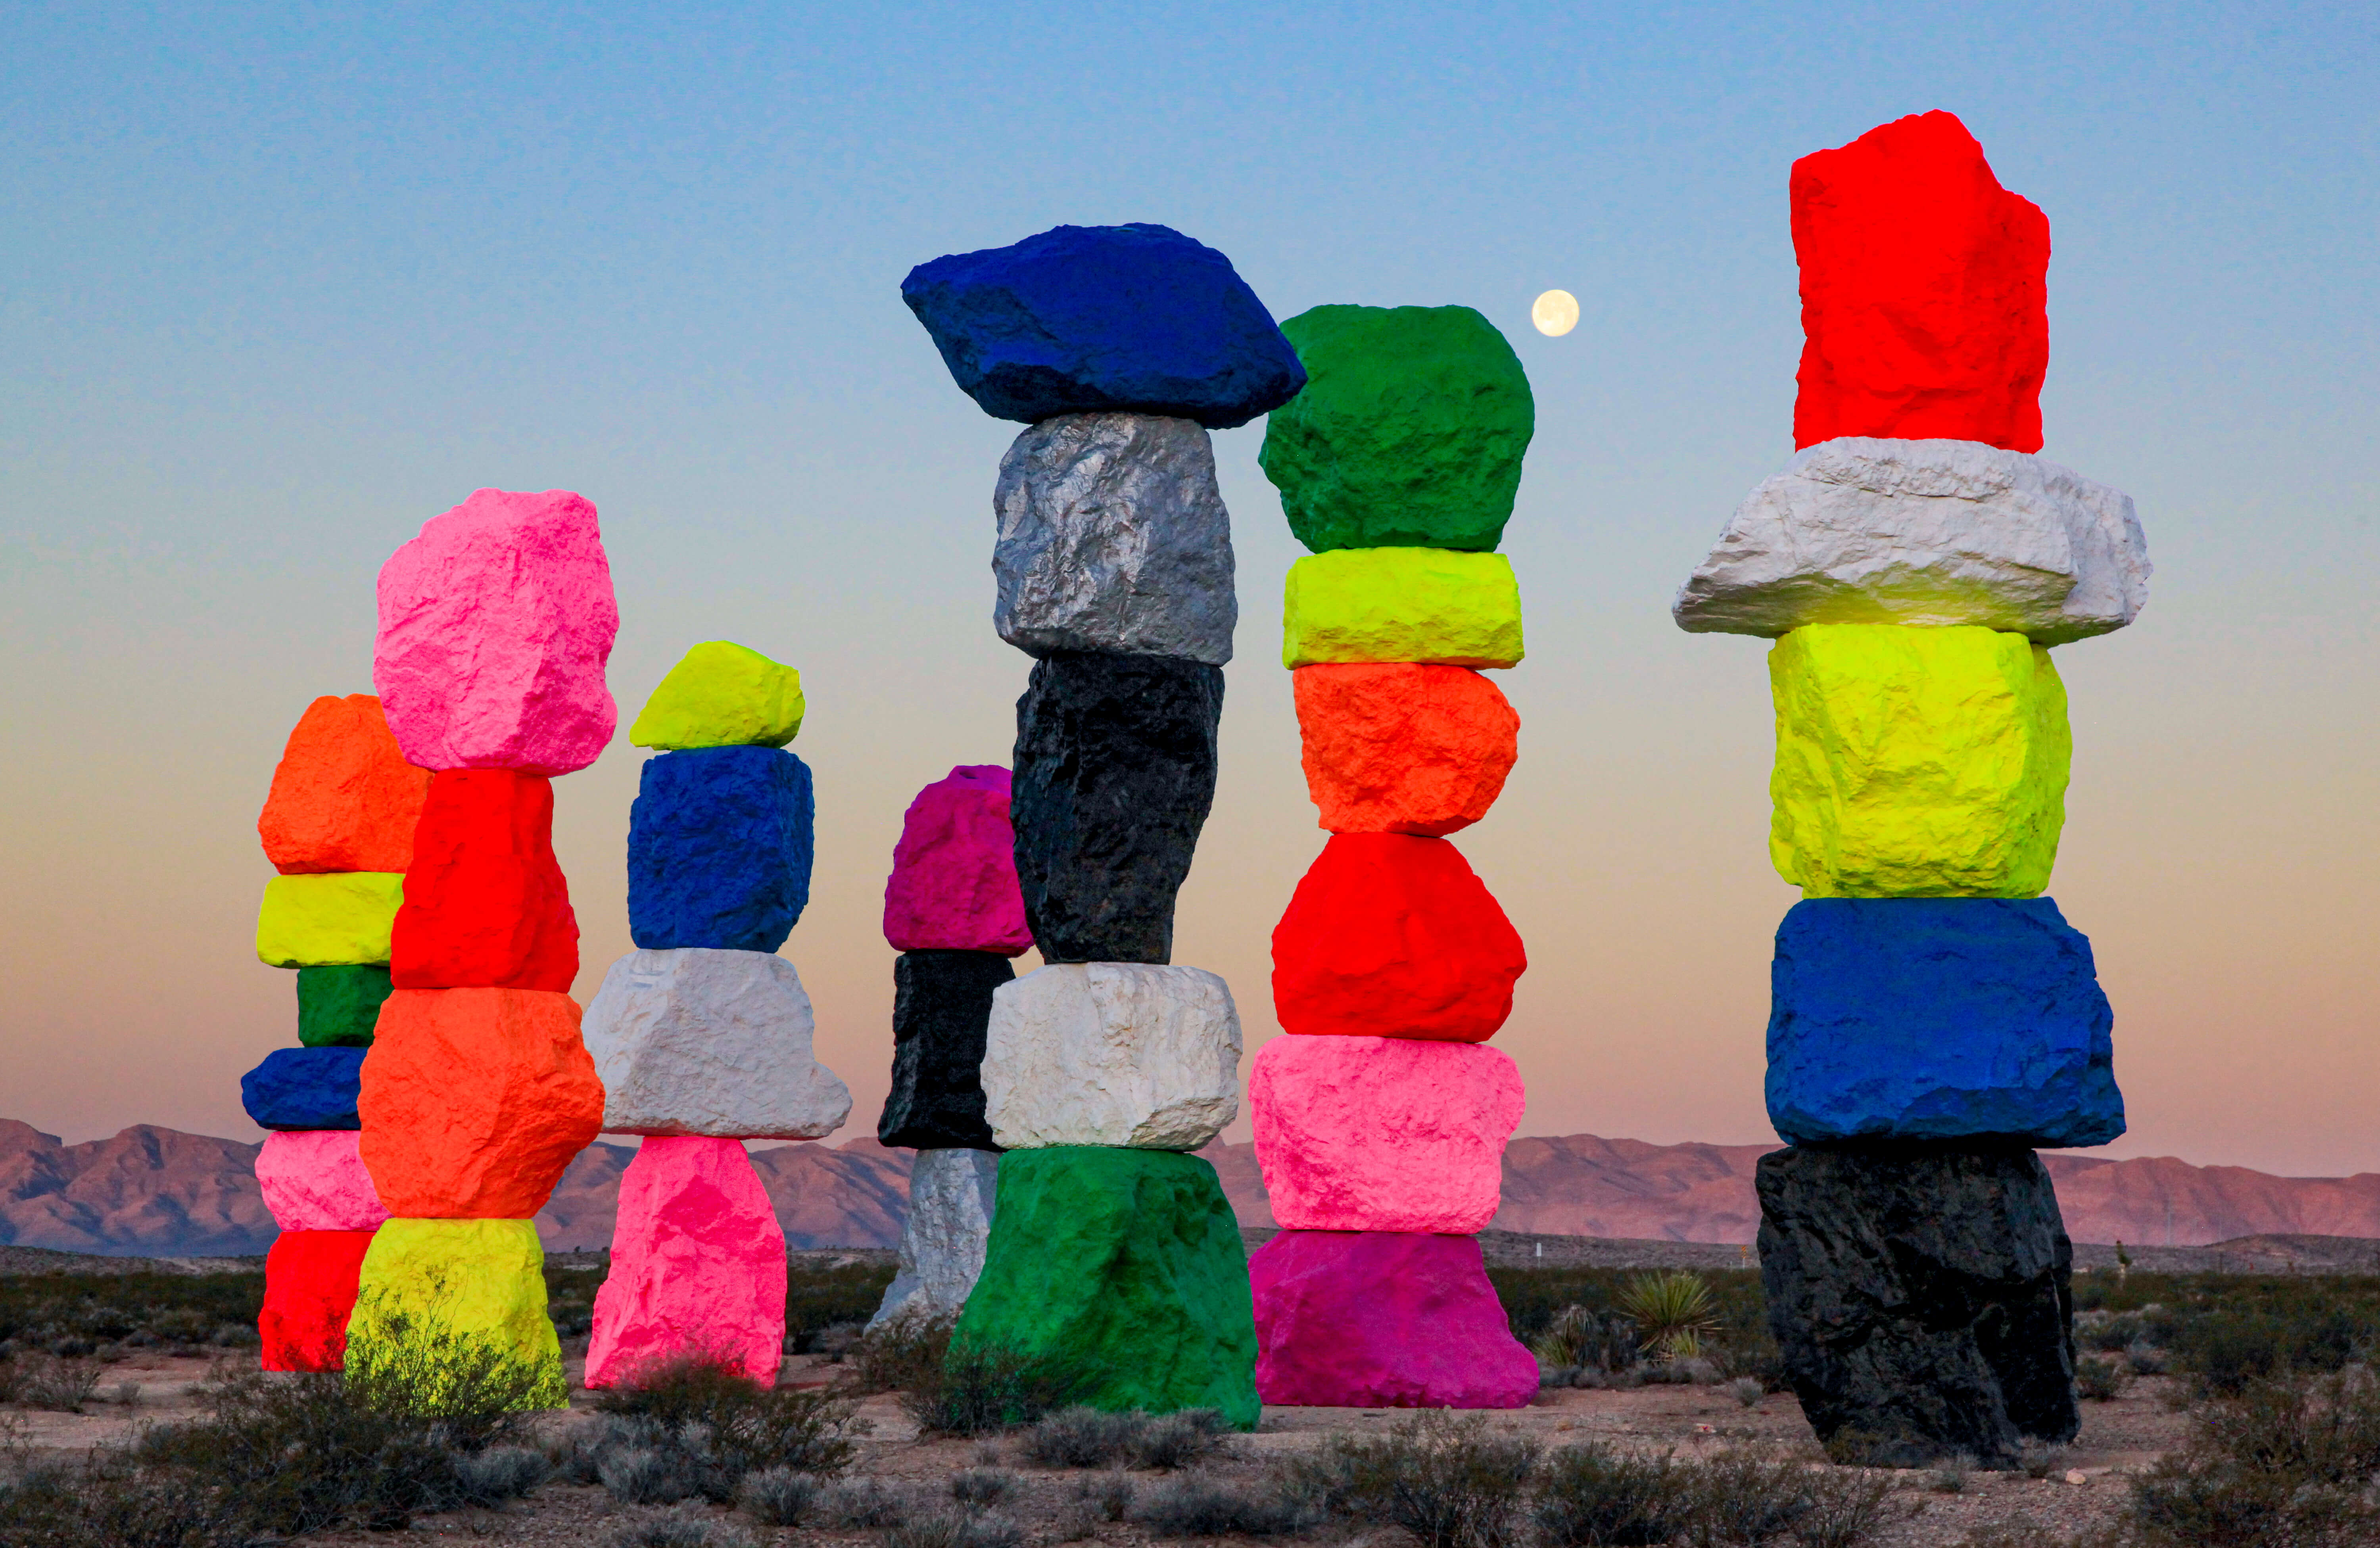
(14, 1119), (2380, 1258)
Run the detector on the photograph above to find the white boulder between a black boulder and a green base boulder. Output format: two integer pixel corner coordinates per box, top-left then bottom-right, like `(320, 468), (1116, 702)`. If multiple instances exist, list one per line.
(983, 962), (1240, 1150)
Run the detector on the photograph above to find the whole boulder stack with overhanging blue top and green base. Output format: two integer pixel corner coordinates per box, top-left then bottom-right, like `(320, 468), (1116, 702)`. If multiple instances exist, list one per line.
(902, 226), (1304, 1427)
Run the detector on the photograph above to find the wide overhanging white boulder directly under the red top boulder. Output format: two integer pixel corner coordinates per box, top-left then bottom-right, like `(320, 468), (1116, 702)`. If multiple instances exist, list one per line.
(1671, 436), (2149, 645)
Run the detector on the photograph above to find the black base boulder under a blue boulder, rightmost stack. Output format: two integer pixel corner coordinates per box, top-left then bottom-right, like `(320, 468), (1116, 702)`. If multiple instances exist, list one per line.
(1759, 1145), (2080, 1467)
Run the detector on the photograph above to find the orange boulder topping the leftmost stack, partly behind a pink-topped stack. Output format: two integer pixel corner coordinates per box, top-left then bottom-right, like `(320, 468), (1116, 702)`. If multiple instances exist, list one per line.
(257, 693), (431, 876)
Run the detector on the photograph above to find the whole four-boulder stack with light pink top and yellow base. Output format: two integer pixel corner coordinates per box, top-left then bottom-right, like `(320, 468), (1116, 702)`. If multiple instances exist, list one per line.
(347, 488), (619, 1405)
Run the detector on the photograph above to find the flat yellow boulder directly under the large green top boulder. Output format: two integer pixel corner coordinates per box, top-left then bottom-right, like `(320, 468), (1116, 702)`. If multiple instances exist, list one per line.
(1280, 548), (1521, 669)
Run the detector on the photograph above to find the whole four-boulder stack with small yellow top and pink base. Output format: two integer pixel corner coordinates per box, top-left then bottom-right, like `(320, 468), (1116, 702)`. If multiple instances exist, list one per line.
(585, 641), (852, 1386)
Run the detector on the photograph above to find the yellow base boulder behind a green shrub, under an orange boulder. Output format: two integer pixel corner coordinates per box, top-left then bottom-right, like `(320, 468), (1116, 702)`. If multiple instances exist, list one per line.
(347, 1220), (571, 1410)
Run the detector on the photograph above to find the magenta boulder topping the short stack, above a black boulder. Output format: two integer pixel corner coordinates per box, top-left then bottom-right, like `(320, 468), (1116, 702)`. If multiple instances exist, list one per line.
(885, 764), (1033, 957)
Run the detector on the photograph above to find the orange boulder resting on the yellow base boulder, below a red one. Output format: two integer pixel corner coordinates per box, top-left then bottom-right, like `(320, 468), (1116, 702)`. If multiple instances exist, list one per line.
(357, 988), (602, 1220)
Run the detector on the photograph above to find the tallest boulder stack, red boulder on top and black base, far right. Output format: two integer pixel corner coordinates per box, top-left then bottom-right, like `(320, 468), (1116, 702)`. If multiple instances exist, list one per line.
(1676, 112), (2149, 1465)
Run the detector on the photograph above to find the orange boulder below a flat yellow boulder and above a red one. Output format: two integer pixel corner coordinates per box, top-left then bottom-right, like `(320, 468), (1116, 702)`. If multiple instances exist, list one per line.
(1290, 662), (1521, 836)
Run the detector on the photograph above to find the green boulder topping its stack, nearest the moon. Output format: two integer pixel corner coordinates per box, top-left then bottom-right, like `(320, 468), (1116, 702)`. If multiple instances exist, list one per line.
(1257, 307), (1537, 553)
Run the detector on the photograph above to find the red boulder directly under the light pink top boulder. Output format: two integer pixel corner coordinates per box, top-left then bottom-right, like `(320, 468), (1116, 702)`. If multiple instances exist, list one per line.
(388, 769), (578, 991)
